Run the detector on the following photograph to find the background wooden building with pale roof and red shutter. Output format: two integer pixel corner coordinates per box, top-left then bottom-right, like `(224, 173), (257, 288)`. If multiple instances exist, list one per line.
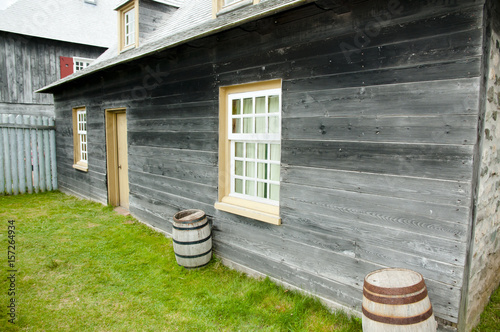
(0, 0), (117, 116)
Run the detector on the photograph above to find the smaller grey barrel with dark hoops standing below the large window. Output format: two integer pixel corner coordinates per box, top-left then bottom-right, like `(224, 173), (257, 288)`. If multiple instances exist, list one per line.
(172, 210), (212, 268)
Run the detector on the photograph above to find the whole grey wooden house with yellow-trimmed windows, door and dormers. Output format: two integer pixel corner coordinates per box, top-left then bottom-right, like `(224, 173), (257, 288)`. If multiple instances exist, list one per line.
(40, 0), (500, 331)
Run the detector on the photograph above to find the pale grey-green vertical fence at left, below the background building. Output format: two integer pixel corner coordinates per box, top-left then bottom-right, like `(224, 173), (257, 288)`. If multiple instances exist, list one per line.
(0, 114), (57, 195)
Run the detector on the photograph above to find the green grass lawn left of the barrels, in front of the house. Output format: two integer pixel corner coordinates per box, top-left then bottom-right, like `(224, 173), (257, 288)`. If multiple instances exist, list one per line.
(0, 192), (361, 331)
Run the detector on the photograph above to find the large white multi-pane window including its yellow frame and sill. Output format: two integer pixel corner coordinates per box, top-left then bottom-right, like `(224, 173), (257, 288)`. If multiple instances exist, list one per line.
(215, 80), (281, 224)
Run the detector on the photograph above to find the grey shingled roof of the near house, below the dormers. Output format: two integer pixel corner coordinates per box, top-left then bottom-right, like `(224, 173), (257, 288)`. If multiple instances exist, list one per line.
(37, 0), (314, 93)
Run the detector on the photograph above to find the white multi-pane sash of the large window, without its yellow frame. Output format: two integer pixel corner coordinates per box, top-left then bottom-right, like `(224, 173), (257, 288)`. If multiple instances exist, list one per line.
(228, 89), (281, 205)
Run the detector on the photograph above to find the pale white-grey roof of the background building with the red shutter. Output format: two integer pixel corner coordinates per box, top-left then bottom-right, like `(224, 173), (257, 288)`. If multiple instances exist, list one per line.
(0, 0), (117, 47)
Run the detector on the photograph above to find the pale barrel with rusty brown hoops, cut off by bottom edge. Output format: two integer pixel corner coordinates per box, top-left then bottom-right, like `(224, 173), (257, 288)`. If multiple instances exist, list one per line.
(362, 268), (437, 332)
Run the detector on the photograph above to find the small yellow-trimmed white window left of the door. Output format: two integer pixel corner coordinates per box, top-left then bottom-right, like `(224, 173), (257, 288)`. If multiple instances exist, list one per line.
(73, 107), (88, 171)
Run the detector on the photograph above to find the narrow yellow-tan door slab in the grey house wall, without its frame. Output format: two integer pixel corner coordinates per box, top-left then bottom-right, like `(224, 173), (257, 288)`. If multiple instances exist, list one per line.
(116, 113), (129, 209)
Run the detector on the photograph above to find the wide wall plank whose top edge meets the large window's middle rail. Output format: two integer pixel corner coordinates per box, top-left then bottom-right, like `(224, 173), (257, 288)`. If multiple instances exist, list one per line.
(281, 140), (473, 181)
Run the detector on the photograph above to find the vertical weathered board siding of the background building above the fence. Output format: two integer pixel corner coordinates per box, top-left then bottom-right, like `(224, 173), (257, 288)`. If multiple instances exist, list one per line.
(0, 31), (106, 114)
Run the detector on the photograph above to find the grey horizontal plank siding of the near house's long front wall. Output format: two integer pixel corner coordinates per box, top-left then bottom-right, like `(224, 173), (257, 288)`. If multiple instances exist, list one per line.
(52, 0), (483, 322)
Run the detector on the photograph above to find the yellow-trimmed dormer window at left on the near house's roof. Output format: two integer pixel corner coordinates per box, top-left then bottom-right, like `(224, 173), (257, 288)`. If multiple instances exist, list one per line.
(116, 0), (139, 51)
